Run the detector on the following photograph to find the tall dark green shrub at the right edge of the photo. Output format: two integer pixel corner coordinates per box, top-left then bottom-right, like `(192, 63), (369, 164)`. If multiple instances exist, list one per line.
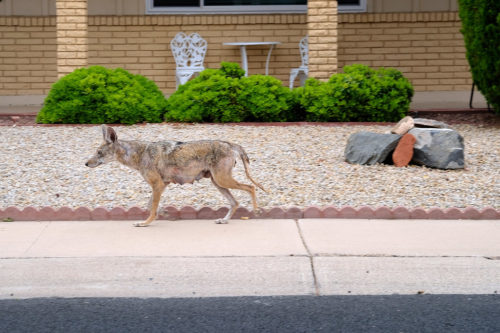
(459, 0), (500, 114)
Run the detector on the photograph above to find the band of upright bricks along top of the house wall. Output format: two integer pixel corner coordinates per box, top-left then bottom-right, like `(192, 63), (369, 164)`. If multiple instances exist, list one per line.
(0, 12), (460, 27)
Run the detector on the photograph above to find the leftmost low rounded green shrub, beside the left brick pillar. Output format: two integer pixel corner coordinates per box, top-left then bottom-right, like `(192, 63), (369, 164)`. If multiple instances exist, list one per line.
(36, 66), (166, 124)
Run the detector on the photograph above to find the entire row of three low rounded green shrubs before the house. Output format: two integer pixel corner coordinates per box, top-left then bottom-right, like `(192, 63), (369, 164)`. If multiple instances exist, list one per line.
(37, 62), (413, 124)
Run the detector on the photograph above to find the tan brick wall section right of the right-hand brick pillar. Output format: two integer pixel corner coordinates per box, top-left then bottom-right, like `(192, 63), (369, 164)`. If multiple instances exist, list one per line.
(338, 12), (472, 91)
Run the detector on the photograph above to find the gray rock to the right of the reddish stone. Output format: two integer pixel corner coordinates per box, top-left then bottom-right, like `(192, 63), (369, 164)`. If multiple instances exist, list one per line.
(408, 128), (464, 169)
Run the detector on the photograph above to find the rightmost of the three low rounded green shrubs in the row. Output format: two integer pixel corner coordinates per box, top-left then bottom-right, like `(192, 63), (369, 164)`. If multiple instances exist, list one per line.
(296, 65), (413, 121)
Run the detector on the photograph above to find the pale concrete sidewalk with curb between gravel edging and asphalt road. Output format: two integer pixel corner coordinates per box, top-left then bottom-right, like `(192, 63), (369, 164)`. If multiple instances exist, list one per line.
(0, 219), (500, 299)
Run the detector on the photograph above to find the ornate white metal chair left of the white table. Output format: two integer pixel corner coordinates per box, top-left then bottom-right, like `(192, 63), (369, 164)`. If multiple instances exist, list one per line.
(170, 32), (207, 88)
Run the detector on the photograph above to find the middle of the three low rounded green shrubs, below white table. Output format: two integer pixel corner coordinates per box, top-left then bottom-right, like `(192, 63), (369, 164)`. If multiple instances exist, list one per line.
(165, 62), (292, 122)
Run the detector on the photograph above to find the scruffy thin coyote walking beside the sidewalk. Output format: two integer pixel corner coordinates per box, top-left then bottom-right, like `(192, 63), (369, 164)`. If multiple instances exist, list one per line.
(85, 125), (267, 227)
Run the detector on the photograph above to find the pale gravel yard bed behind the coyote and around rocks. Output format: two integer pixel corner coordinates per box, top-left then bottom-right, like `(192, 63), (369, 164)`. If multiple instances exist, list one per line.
(0, 124), (500, 209)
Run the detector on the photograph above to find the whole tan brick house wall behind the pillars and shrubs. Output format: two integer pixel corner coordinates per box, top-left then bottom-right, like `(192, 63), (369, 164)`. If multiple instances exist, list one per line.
(0, 10), (472, 96)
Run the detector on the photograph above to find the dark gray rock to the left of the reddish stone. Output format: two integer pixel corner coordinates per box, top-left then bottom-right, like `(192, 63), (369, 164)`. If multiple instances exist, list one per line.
(344, 131), (401, 165)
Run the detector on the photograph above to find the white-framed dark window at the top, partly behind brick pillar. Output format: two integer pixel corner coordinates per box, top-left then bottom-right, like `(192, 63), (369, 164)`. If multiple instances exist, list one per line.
(146, 0), (366, 14)
